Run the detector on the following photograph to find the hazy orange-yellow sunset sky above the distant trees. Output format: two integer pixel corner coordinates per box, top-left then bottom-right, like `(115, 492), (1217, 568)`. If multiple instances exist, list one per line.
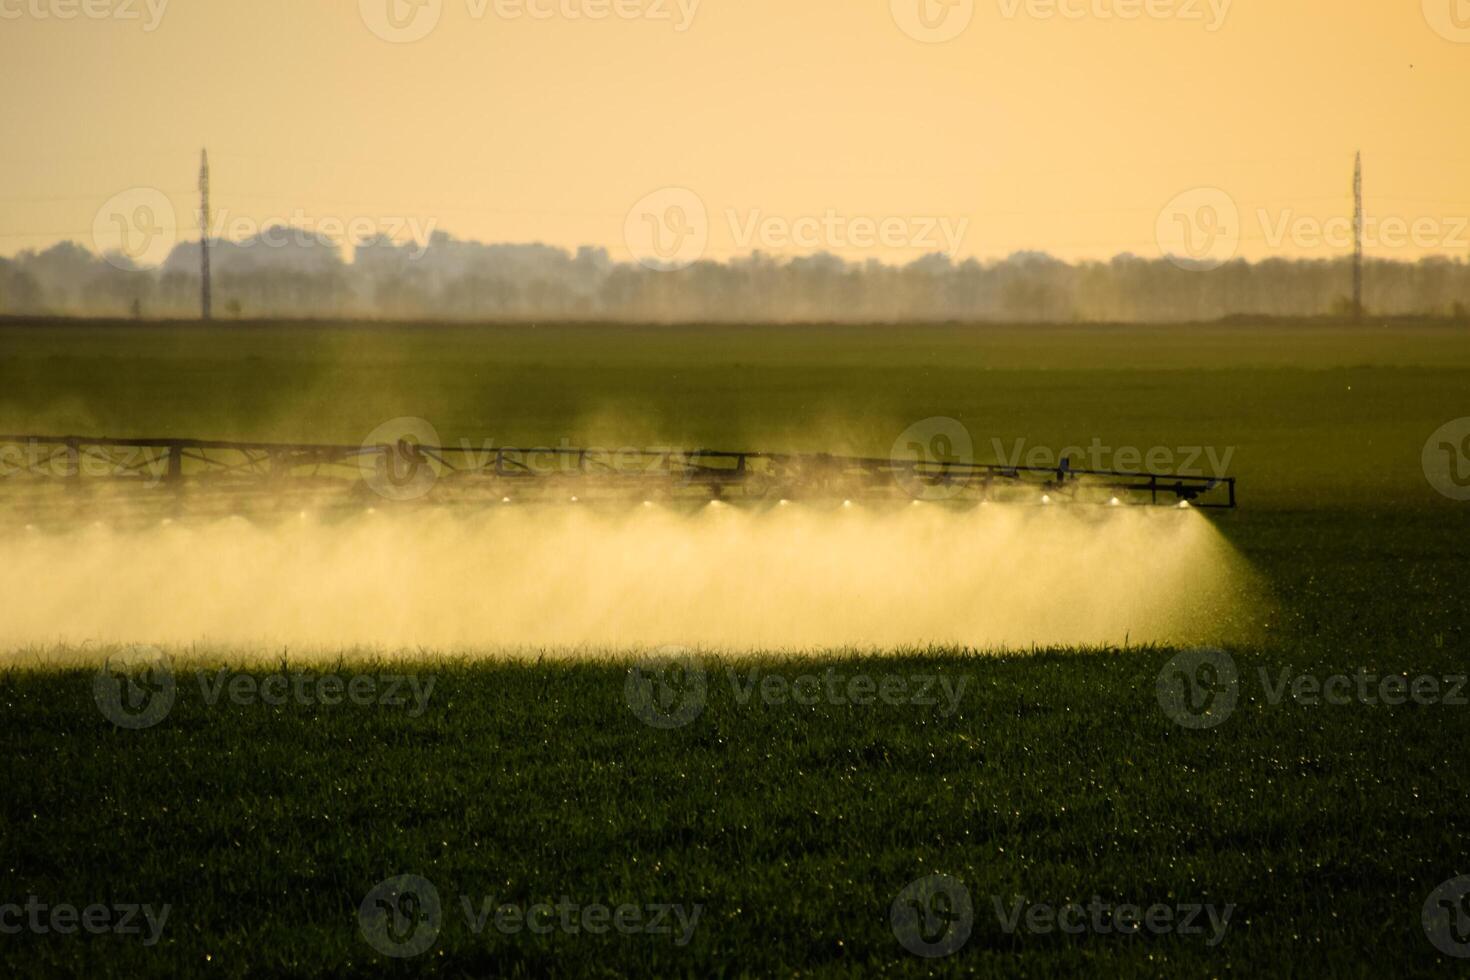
(0, 0), (1470, 268)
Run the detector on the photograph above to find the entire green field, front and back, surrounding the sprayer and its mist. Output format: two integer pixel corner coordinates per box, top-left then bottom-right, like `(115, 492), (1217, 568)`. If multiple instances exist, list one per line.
(0, 323), (1470, 976)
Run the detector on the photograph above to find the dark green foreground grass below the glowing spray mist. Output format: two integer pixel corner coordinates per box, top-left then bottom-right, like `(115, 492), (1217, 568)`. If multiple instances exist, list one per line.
(0, 628), (1470, 976)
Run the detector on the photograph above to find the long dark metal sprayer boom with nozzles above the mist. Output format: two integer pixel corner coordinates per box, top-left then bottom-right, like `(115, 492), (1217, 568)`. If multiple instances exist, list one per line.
(0, 436), (1235, 508)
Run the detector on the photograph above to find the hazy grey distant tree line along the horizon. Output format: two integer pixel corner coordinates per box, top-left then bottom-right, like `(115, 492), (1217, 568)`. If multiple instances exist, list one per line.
(0, 232), (1470, 322)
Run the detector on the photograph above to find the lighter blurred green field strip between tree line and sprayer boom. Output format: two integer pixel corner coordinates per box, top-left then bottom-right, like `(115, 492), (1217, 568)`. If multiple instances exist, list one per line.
(0, 322), (1470, 508)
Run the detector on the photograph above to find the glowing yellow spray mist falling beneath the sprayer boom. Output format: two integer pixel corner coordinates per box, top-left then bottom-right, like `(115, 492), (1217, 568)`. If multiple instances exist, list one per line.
(0, 502), (1254, 655)
